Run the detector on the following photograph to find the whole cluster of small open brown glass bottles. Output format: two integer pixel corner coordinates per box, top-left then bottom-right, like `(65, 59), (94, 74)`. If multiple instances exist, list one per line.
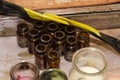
(17, 21), (90, 69)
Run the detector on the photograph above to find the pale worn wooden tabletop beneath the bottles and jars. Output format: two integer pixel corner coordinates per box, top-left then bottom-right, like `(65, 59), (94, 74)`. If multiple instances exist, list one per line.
(0, 28), (120, 80)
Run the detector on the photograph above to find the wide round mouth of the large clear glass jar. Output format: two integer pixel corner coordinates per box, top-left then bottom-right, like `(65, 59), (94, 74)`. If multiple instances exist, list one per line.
(72, 47), (107, 75)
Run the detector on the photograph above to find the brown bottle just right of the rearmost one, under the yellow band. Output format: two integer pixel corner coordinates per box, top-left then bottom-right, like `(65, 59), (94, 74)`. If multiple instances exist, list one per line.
(47, 22), (59, 35)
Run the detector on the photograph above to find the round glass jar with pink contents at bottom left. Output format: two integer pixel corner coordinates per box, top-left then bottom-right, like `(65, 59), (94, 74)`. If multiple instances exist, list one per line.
(10, 62), (39, 80)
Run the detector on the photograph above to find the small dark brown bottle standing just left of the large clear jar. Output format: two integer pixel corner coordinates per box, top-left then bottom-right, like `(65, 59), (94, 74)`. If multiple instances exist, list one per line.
(64, 36), (78, 62)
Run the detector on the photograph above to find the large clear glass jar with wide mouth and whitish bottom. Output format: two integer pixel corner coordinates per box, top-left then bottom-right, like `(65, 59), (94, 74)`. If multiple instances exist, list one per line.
(69, 47), (107, 80)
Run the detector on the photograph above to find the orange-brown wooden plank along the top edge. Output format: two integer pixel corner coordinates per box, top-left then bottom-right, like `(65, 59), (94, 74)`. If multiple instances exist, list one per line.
(6, 0), (120, 9)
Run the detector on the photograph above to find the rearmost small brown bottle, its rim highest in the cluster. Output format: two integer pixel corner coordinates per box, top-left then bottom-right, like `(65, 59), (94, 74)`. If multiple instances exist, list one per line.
(34, 21), (45, 34)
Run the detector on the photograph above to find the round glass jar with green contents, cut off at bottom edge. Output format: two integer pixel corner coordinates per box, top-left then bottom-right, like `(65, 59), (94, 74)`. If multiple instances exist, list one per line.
(39, 69), (68, 80)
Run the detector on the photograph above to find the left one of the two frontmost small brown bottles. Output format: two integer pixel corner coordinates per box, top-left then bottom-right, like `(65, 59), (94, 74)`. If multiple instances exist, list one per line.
(35, 44), (47, 70)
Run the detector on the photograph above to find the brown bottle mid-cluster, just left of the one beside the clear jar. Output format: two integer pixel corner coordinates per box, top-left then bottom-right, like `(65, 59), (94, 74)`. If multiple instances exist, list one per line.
(53, 31), (66, 56)
